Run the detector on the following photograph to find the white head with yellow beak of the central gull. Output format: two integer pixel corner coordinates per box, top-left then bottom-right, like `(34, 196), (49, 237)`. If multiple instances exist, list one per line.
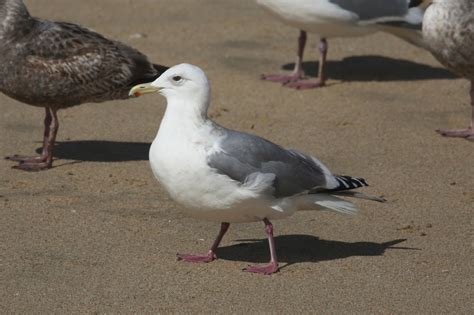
(129, 63), (210, 103)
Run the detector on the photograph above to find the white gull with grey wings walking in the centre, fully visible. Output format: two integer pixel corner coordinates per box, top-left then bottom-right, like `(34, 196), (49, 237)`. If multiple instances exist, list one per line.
(130, 64), (384, 274)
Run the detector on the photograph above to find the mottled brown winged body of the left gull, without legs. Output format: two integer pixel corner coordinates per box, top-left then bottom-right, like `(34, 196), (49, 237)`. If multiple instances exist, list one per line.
(0, 20), (166, 107)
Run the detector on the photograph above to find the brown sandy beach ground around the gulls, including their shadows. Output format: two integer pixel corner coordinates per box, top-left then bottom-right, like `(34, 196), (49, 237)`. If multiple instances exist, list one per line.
(0, 0), (474, 314)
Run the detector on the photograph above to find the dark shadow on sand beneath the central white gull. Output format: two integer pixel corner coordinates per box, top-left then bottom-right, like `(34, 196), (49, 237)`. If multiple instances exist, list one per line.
(217, 234), (419, 266)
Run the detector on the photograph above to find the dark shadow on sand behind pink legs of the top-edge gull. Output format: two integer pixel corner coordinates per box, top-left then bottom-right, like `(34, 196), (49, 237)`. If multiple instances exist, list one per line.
(282, 55), (458, 81)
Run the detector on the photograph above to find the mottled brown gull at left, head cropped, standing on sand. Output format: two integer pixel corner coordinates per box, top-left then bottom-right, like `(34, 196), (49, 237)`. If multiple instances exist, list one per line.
(0, 0), (168, 171)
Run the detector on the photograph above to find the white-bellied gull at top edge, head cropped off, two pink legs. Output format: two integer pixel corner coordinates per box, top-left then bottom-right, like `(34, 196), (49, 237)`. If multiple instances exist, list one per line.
(257, 0), (431, 89)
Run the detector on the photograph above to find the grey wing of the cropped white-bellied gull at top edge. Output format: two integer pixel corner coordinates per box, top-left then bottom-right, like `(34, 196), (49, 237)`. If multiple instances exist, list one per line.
(328, 0), (409, 21)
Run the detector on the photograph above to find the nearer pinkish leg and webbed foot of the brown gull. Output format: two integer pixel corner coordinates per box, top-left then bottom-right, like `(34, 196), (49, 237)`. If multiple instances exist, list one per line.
(13, 108), (59, 171)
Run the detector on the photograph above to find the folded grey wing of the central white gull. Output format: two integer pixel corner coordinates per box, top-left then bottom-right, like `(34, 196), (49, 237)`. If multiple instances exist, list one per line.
(208, 130), (330, 197)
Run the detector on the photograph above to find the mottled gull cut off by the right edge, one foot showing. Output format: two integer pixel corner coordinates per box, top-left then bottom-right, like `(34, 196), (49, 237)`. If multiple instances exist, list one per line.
(423, 0), (474, 141)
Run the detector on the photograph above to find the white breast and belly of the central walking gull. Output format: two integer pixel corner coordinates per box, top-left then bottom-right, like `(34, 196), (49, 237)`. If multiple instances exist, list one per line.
(150, 124), (302, 222)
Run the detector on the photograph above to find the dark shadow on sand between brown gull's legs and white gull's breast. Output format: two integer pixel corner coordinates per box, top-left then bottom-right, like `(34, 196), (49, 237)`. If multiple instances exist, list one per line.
(36, 140), (151, 162)
